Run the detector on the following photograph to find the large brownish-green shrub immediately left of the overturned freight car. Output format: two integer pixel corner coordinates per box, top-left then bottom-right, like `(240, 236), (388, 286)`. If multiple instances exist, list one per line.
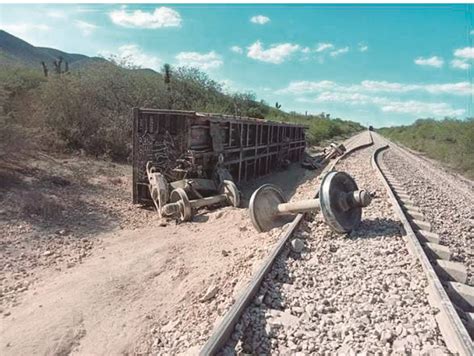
(34, 62), (165, 160)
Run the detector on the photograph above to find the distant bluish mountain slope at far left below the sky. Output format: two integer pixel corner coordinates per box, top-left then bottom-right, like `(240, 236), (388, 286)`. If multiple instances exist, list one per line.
(0, 30), (99, 68)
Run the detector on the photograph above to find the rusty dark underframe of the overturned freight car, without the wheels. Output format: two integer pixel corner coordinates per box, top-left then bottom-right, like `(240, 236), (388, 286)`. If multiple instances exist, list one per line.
(132, 108), (307, 204)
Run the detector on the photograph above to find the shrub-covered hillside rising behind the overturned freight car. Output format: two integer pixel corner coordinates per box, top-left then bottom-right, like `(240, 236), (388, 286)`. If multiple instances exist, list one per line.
(0, 31), (363, 161)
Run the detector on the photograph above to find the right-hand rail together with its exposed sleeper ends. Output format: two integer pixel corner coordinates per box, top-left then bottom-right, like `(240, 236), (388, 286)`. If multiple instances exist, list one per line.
(372, 140), (474, 356)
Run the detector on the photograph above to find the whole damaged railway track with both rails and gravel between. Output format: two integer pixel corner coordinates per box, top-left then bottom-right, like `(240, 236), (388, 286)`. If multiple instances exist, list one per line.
(200, 133), (474, 355)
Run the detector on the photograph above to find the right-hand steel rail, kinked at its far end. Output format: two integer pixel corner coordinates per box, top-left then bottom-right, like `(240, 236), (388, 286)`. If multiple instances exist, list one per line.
(372, 145), (474, 356)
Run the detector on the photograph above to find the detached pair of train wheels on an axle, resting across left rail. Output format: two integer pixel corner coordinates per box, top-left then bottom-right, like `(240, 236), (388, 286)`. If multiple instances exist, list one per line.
(249, 172), (371, 234)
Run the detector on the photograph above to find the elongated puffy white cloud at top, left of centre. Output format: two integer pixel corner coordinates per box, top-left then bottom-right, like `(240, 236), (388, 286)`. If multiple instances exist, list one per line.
(109, 6), (181, 29)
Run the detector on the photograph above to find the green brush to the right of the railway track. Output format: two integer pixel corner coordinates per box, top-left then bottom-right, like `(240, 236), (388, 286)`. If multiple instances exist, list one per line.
(377, 118), (474, 179)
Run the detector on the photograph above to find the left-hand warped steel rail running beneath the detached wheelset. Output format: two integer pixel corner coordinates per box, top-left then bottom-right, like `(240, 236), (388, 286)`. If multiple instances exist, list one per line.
(199, 131), (374, 356)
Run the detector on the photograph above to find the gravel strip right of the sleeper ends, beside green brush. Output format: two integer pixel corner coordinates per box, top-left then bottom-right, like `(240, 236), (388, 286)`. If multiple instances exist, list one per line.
(384, 136), (474, 286)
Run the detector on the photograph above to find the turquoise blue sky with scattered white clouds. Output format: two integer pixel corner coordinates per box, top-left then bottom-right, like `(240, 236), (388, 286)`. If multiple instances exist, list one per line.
(0, 4), (474, 126)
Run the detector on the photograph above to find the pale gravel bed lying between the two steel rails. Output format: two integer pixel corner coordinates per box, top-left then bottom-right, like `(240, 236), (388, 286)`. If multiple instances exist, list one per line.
(201, 134), (470, 355)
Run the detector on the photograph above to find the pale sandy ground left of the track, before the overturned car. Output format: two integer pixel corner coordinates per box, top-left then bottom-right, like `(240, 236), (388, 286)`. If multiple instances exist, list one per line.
(0, 146), (326, 355)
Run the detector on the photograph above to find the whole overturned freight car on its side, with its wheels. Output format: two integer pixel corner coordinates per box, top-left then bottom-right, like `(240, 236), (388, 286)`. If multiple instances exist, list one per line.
(133, 108), (306, 220)
